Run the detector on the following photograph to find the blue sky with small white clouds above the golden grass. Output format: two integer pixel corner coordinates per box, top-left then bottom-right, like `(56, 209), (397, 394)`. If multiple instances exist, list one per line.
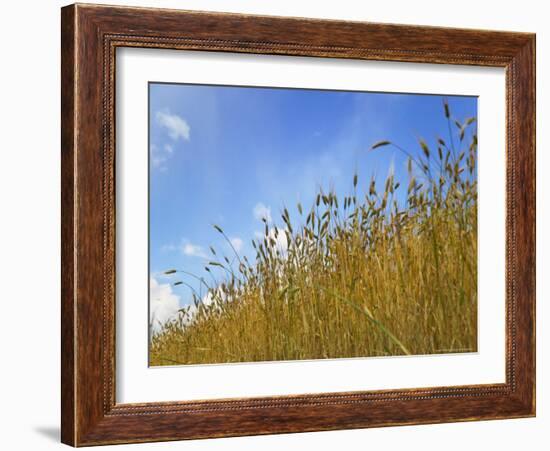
(149, 83), (477, 305)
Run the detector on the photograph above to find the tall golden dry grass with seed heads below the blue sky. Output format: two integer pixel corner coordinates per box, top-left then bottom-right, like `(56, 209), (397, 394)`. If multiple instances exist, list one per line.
(150, 103), (477, 365)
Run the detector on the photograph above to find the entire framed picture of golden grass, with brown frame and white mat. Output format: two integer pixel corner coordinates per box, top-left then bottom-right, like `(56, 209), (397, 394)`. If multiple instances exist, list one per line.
(61, 4), (535, 446)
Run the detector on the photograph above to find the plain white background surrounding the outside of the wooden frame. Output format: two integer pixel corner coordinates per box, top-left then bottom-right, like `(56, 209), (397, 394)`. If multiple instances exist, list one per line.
(0, 0), (550, 451)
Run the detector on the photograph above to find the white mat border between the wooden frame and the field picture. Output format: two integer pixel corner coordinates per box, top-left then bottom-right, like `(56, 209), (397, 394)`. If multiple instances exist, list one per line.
(116, 48), (506, 403)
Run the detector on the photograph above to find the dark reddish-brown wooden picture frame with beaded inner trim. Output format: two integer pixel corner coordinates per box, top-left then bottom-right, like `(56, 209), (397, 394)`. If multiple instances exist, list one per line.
(61, 4), (535, 446)
